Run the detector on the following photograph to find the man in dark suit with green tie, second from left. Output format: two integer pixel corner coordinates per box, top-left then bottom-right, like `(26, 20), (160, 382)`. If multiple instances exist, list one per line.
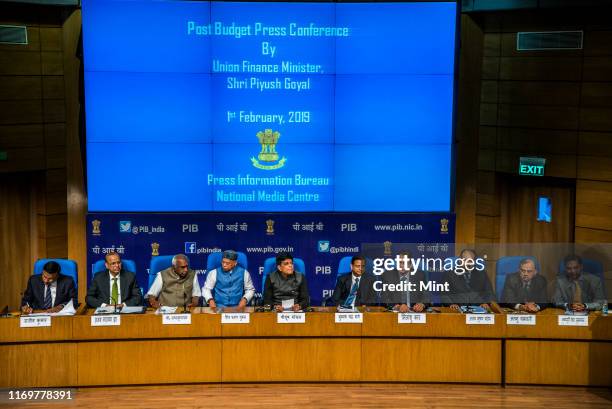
(86, 252), (142, 308)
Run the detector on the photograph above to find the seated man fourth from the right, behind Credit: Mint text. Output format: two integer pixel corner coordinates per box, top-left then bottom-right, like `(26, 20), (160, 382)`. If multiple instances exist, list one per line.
(381, 253), (430, 312)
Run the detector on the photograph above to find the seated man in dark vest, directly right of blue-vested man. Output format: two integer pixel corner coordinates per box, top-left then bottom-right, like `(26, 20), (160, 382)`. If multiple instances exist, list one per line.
(263, 253), (310, 312)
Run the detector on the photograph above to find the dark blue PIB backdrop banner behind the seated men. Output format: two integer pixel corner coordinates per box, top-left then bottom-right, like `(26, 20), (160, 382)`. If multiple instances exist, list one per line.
(87, 213), (455, 305)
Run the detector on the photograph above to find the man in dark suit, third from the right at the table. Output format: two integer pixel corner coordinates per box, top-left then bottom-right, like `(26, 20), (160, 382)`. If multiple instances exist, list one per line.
(440, 249), (495, 311)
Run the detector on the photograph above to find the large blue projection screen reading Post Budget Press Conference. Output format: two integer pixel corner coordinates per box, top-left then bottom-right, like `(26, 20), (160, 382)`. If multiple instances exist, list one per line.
(82, 0), (457, 212)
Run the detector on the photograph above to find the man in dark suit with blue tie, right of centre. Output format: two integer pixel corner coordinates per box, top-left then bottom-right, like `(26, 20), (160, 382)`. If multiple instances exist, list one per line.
(333, 256), (377, 308)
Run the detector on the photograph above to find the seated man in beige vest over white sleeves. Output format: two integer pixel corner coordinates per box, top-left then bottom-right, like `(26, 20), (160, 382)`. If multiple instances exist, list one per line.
(147, 254), (202, 308)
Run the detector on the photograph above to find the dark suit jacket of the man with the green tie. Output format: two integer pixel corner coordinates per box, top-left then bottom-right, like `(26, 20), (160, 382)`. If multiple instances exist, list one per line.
(85, 270), (142, 308)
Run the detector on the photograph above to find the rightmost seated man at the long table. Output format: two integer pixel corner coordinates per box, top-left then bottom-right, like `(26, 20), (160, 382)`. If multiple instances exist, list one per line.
(553, 255), (606, 311)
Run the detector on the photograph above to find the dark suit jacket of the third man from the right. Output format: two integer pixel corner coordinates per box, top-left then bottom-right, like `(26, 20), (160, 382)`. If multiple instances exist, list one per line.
(440, 269), (495, 305)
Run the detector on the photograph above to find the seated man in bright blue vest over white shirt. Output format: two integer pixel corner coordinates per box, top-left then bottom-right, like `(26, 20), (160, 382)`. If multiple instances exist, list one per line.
(202, 250), (255, 310)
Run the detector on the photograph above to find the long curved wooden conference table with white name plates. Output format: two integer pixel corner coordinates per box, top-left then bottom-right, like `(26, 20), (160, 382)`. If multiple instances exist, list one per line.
(0, 308), (612, 388)
